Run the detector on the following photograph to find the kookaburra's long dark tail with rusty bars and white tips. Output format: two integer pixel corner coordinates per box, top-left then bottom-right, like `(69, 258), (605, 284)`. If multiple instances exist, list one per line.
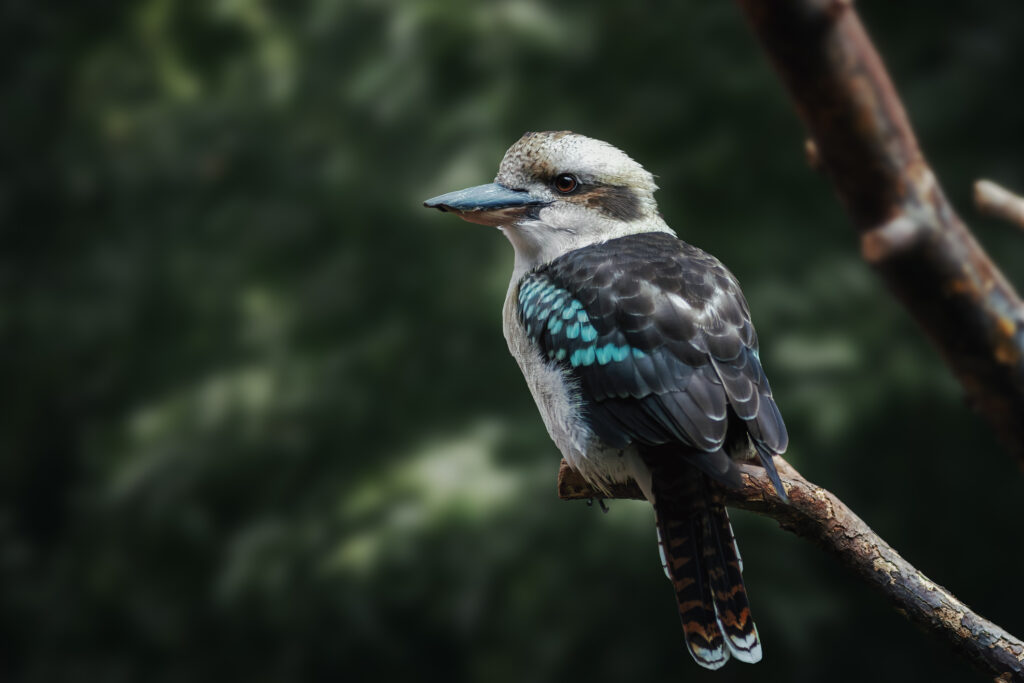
(654, 472), (761, 669)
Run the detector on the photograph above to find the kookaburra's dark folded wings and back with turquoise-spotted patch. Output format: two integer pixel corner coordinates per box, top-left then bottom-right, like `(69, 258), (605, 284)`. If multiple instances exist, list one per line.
(518, 232), (788, 466)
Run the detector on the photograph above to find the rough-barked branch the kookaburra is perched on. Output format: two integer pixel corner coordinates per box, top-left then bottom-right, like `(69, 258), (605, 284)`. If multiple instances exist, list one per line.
(558, 456), (1024, 681)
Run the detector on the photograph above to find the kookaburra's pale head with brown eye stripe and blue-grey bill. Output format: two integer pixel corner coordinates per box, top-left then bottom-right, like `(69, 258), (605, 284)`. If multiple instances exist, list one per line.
(423, 131), (671, 269)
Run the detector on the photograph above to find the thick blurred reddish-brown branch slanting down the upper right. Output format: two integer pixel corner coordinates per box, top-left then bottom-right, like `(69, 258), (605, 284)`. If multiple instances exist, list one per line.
(737, 0), (1024, 465)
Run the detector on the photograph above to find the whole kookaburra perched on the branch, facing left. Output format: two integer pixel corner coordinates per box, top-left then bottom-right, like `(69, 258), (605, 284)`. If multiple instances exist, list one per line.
(424, 131), (788, 670)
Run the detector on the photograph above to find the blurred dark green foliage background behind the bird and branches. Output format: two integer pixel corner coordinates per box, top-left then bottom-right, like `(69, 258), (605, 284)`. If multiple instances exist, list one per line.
(0, 0), (1024, 682)
